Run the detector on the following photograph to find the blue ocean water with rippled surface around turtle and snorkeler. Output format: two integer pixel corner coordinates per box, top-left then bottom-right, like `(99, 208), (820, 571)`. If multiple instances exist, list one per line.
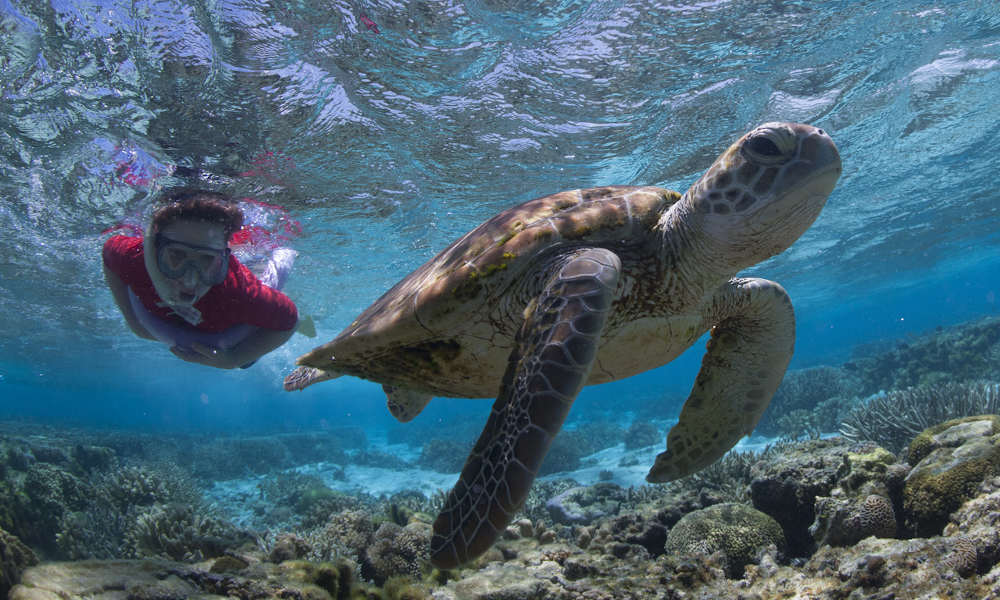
(0, 0), (1000, 440)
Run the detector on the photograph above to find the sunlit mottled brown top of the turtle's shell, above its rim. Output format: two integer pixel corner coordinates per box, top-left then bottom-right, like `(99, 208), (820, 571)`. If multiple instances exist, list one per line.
(298, 186), (681, 383)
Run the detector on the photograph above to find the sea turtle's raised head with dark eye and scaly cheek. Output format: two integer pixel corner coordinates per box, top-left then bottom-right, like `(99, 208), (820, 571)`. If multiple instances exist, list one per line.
(685, 123), (841, 268)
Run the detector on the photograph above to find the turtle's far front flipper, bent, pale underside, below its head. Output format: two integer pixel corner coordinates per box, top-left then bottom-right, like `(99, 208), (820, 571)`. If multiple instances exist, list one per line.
(646, 279), (795, 483)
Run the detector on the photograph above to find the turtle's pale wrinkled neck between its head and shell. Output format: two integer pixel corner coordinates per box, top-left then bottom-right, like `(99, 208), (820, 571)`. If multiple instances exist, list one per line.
(656, 194), (739, 310)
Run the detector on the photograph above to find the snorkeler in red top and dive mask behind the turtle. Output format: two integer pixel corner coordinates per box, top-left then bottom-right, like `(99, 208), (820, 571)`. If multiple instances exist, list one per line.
(103, 188), (298, 369)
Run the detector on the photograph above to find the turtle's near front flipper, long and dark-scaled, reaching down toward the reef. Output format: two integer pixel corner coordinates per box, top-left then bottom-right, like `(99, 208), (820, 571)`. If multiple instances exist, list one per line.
(431, 248), (621, 568)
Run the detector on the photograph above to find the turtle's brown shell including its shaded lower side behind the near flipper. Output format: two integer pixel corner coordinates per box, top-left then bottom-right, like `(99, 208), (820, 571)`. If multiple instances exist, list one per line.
(297, 186), (680, 395)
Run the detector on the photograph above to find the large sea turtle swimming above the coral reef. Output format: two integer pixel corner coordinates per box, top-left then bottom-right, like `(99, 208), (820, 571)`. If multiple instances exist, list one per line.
(285, 123), (841, 568)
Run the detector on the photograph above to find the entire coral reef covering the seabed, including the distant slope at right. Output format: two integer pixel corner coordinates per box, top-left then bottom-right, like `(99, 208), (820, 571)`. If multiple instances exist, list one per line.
(9, 314), (1000, 600)
